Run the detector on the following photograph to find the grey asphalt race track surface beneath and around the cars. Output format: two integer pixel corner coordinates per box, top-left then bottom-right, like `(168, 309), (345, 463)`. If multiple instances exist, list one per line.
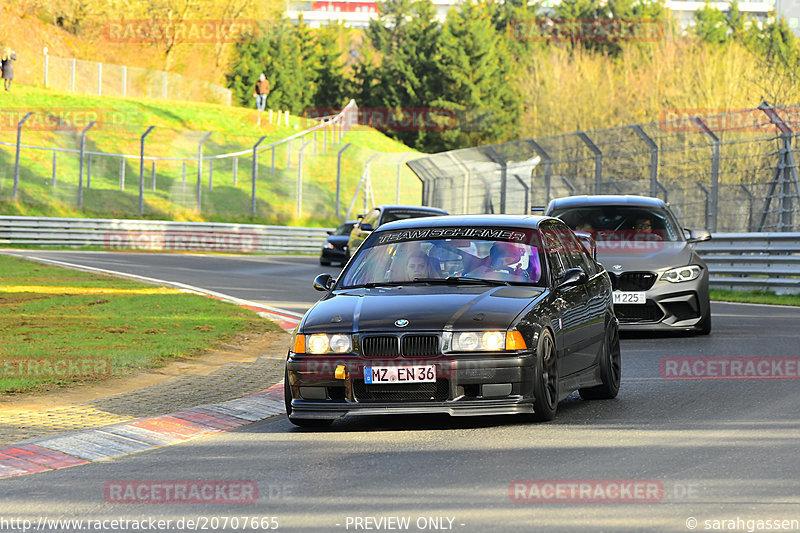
(0, 251), (800, 532)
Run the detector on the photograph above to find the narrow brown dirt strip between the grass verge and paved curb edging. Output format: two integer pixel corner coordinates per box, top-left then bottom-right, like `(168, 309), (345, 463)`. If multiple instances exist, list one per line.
(0, 332), (291, 414)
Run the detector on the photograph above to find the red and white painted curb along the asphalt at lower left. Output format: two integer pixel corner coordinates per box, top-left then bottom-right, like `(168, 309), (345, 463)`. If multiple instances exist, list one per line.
(0, 383), (286, 478)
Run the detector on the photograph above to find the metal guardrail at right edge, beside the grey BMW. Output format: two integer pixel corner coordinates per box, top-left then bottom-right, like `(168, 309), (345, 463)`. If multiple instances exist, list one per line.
(697, 233), (800, 294)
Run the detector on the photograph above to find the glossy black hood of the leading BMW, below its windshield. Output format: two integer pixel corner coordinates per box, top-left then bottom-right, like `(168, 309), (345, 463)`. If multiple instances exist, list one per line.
(301, 285), (544, 334)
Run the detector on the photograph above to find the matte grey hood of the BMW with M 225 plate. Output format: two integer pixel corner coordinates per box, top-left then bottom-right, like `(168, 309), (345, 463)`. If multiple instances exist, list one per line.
(597, 241), (692, 272)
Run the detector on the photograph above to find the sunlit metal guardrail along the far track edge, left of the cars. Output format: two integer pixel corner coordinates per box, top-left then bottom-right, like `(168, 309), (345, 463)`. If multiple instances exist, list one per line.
(0, 216), (328, 254)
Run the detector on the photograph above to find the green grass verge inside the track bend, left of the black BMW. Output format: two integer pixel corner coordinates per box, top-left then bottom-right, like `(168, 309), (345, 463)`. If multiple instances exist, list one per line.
(0, 255), (280, 394)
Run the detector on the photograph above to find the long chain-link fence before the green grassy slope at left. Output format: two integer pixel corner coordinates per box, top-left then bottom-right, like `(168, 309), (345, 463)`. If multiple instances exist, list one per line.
(0, 101), (406, 223)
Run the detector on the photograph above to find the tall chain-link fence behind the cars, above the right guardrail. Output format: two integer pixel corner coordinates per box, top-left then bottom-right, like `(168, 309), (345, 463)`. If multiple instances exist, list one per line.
(408, 104), (800, 232)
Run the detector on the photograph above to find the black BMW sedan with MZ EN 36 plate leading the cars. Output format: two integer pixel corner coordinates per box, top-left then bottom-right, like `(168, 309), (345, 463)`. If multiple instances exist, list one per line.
(284, 215), (620, 426)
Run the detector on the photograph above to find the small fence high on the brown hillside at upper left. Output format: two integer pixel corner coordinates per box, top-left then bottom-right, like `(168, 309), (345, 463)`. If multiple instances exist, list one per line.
(44, 55), (232, 105)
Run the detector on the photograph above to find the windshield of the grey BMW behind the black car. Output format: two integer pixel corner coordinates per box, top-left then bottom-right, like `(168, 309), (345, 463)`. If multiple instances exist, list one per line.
(552, 206), (683, 244)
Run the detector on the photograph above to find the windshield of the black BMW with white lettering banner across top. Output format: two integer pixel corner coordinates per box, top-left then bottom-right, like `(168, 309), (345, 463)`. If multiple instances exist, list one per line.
(337, 227), (546, 289)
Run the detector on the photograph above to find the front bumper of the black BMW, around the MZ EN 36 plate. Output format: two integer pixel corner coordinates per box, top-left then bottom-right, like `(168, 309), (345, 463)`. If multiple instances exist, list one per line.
(286, 353), (535, 419)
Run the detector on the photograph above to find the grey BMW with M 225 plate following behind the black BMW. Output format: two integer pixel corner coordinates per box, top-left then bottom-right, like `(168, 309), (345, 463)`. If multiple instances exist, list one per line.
(546, 195), (711, 335)
